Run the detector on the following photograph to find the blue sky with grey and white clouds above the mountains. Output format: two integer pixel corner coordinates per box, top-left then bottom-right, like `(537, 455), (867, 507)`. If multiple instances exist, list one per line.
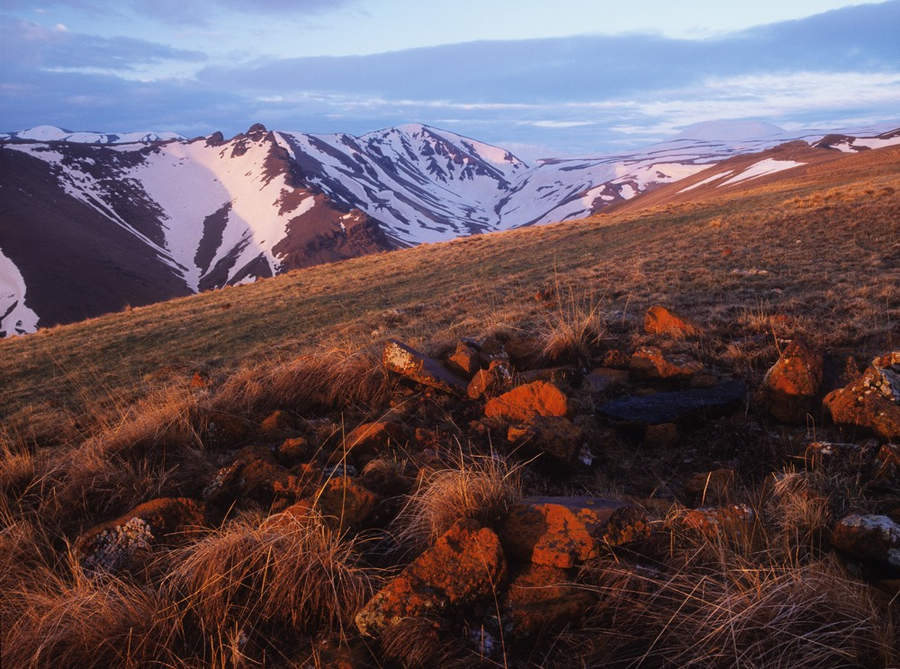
(0, 0), (900, 159)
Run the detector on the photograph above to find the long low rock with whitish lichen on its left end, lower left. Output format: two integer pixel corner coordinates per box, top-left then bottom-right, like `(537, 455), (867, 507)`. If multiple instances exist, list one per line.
(75, 497), (204, 572)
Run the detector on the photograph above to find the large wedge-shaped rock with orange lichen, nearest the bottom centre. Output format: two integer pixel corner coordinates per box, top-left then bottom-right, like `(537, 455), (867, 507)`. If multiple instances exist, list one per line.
(356, 520), (506, 636)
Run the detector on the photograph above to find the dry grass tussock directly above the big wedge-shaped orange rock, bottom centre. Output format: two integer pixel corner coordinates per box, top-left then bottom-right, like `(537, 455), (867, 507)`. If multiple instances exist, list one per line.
(392, 454), (522, 550)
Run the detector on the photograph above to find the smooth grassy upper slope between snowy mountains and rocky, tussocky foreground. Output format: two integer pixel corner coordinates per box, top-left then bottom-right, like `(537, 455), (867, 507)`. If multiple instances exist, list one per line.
(0, 148), (900, 428)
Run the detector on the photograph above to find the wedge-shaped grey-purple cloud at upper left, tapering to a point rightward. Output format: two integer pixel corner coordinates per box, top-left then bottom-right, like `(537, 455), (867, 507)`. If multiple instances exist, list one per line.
(0, 16), (206, 69)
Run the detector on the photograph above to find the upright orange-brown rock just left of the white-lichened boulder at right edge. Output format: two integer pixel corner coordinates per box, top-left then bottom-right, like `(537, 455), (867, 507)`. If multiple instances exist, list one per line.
(760, 337), (824, 423)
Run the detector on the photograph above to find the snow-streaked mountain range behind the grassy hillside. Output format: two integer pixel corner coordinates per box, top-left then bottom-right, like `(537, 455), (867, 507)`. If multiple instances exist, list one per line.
(0, 124), (900, 336)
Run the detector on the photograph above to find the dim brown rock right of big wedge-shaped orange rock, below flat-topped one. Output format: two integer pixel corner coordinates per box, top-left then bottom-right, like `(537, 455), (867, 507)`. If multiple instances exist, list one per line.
(503, 564), (594, 639)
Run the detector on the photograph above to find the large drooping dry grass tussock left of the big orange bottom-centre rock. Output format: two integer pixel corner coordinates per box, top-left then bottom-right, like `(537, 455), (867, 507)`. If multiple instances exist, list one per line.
(165, 506), (373, 637)
